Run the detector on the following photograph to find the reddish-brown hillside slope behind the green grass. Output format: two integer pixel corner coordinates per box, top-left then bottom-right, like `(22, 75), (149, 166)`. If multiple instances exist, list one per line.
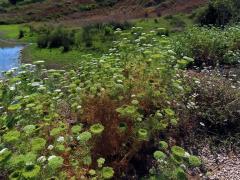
(0, 0), (207, 25)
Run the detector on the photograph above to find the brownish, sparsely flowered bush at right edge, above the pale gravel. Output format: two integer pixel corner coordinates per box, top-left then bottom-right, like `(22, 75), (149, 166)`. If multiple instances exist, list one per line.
(188, 72), (240, 143)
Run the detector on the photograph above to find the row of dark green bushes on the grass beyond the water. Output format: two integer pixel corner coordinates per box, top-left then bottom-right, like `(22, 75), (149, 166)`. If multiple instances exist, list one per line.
(34, 22), (132, 52)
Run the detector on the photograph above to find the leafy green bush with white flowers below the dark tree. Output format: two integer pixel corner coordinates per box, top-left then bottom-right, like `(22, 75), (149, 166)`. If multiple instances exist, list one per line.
(172, 26), (240, 67)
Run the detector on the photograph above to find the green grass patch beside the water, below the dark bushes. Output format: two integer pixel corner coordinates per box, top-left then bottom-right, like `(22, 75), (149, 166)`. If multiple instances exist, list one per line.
(23, 44), (100, 68)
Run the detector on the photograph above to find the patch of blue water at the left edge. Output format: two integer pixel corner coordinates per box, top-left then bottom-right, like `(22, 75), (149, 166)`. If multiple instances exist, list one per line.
(0, 46), (23, 73)
